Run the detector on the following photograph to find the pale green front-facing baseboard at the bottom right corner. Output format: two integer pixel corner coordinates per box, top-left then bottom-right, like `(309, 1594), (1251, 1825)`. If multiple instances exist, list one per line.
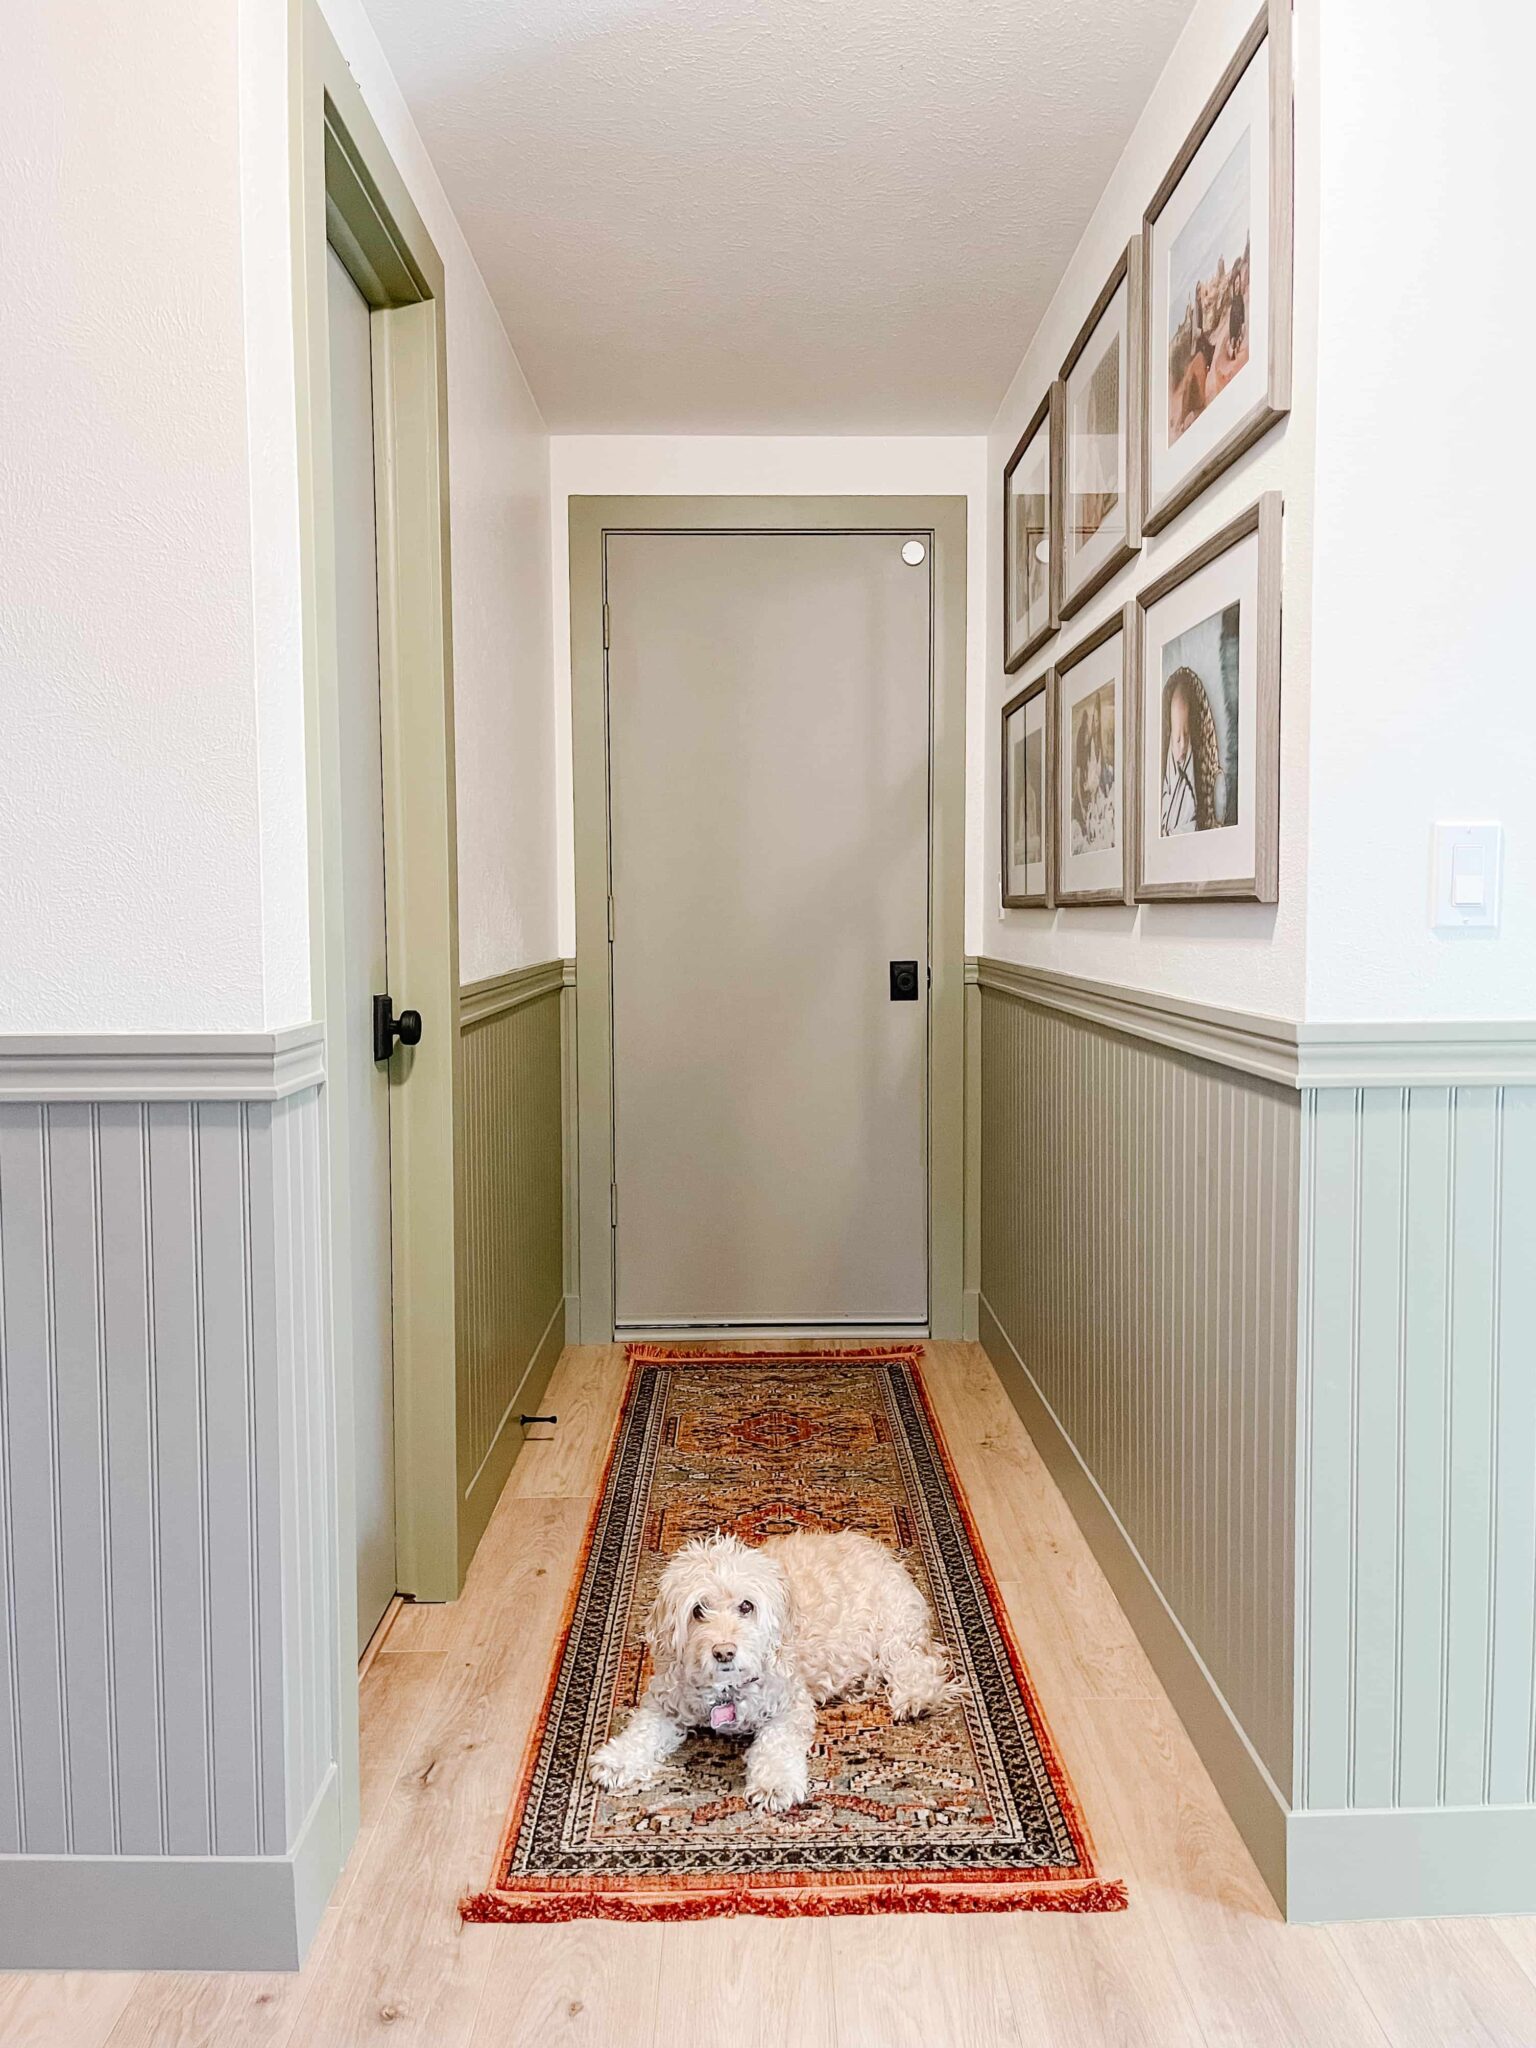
(1286, 1806), (1536, 1921)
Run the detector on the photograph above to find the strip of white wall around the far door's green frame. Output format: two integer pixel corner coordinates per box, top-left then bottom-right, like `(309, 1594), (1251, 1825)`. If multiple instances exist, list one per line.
(549, 434), (987, 954)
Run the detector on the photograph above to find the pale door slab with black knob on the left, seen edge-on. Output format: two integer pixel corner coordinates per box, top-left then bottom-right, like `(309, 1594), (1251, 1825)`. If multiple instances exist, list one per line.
(328, 250), (397, 1653)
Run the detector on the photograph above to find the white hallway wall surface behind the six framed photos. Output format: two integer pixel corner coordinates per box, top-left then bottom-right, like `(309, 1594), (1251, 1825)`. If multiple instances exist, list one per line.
(991, 0), (1317, 1016)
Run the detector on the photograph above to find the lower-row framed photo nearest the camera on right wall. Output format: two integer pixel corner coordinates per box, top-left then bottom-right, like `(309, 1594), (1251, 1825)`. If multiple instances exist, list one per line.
(1133, 492), (1282, 903)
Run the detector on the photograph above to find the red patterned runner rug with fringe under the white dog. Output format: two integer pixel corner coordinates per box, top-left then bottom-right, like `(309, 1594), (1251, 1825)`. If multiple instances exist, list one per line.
(461, 1343), (1126, 1921)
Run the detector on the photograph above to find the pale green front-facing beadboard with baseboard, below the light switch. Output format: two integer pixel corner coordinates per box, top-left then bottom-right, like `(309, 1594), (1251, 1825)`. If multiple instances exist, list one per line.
(1290, 1089), (1536, 1919)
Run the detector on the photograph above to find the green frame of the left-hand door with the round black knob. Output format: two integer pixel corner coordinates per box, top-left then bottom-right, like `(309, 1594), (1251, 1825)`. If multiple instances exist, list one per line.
(289, 0), (467, 1812)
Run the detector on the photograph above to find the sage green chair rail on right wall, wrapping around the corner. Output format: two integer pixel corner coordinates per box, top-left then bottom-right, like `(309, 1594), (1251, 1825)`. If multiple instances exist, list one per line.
(967, 956), (1536, 1087)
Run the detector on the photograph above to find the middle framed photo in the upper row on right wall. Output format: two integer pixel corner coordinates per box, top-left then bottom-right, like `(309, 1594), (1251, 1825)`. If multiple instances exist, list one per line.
(1061, 236), (1145, 618)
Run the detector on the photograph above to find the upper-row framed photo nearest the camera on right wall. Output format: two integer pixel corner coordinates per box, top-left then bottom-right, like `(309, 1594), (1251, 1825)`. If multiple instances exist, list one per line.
(1141, 0), (1294, 535)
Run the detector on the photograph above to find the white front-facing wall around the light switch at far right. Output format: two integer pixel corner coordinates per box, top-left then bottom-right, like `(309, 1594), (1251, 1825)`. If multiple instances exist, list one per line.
(1307, 0), (1536, 1018)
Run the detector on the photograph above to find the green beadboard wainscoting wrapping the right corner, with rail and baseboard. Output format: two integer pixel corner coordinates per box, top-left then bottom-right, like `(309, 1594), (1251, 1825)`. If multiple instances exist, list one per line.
(971, 961), (1536, 1919)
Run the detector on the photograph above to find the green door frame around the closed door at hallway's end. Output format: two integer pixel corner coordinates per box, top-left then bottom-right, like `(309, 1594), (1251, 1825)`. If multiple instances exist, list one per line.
(569, 496), (967, 1343)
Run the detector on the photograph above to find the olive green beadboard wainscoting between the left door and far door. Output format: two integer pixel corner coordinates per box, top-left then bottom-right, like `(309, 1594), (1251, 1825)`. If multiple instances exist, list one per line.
(459, 961), (567, 1569)
